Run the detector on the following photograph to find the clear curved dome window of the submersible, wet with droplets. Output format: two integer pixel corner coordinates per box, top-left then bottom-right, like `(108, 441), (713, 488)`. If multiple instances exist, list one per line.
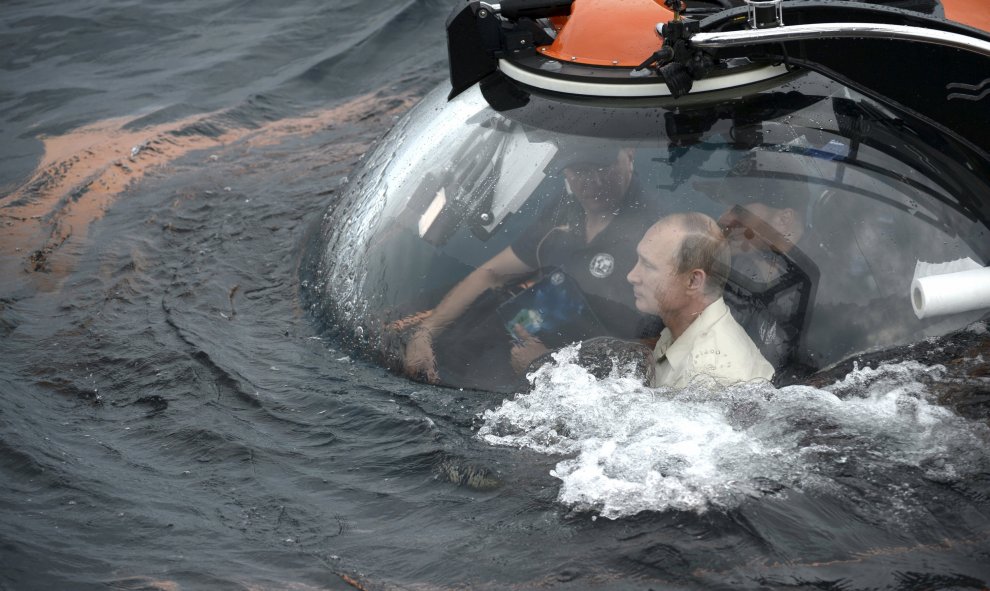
(319, 74), (990, 390)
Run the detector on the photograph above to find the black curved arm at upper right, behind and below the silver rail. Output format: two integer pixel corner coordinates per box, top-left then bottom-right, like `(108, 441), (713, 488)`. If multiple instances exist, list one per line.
(700, 0), (990, 159)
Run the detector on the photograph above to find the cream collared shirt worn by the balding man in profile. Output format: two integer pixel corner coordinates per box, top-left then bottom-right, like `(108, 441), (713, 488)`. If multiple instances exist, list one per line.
(653, 298), (773, 388)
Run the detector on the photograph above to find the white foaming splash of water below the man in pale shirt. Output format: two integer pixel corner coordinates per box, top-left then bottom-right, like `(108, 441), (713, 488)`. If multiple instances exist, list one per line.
(478, 346), (990, 519)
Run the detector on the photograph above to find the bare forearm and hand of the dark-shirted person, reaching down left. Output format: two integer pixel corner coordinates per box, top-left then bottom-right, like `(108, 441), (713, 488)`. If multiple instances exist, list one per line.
(403, 248), (533, 382)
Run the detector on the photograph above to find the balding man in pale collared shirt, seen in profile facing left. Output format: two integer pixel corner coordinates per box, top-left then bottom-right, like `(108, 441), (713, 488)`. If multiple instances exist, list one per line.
(626, 213), (773, 388)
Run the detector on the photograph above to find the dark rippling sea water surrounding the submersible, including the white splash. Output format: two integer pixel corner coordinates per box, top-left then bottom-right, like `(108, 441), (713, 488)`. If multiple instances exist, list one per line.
(0, 0), (990, 591)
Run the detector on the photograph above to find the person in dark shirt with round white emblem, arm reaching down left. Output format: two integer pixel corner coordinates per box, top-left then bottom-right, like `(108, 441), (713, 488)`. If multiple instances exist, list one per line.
(403, 147), (658, 383)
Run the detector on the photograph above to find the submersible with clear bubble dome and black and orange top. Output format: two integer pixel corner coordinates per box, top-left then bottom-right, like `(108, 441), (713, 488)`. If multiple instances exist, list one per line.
(316, 0), (990, 390)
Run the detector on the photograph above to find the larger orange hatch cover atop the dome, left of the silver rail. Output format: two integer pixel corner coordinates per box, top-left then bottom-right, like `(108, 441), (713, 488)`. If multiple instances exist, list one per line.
(539, 0), (674, 68)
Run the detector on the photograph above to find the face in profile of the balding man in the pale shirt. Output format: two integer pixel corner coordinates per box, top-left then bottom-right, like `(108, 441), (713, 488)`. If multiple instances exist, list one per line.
(626, 224), (689, 318)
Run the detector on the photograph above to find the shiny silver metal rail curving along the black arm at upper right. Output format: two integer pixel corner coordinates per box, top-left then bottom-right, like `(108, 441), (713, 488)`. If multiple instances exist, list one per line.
(688, 23), (990, 57)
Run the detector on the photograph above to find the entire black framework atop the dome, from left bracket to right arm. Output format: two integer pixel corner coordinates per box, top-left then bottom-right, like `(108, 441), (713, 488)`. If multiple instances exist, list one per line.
(447, 0), (990, 160)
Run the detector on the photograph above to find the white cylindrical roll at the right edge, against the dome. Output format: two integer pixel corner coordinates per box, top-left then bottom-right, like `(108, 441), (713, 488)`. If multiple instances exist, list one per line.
(911, 267), (990, 319)
